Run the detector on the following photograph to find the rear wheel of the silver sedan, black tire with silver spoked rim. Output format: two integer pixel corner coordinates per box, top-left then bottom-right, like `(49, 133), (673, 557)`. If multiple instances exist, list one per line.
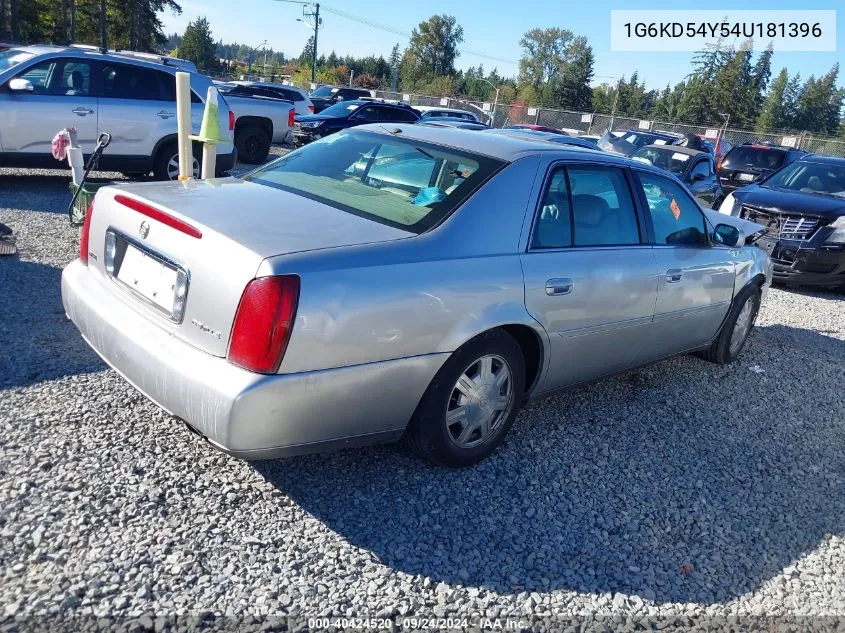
(405, 330), (525, 468)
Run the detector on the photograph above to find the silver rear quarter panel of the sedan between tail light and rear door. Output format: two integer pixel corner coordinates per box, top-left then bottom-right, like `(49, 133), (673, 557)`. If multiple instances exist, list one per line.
(259, 156), (547, 373)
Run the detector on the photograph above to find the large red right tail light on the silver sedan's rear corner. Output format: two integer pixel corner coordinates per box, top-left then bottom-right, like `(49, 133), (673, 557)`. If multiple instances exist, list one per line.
(226, 275), (299, 374)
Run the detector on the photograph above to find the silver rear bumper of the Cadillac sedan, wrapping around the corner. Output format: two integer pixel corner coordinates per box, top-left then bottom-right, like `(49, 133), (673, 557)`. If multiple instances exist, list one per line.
(62, 260), (448, 459)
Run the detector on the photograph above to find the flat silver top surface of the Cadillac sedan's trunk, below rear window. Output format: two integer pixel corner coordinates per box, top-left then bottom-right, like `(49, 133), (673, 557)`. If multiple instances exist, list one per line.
(110, 178), (414, 257)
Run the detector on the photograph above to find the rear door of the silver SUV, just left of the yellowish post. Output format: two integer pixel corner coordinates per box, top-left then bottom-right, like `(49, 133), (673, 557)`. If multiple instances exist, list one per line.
(97, 61), (181, 162)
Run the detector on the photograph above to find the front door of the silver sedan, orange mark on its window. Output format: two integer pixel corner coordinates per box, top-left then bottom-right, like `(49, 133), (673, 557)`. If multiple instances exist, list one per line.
(635, 170), (735, 361)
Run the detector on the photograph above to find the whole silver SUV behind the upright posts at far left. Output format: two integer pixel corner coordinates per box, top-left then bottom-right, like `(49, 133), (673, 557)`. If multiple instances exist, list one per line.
(0, 46), (235, 180)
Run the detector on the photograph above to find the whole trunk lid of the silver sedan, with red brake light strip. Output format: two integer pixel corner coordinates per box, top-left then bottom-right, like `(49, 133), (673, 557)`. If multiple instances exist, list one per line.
(89, 179), (413, 356)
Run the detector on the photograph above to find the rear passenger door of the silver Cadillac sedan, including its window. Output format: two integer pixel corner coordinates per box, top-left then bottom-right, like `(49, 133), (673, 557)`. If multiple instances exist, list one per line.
(521, 164), (657, 389)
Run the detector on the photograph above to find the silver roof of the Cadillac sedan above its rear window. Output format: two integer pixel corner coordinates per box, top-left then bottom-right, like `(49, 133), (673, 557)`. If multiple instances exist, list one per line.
(353, 123), (644, 165)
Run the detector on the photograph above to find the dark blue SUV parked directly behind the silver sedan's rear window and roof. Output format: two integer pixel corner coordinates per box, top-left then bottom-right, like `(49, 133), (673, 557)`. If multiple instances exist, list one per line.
(293, 100), (420, 145)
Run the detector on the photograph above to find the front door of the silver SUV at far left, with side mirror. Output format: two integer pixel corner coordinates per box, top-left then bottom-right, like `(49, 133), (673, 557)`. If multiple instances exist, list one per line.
(0, 58), (98, 158)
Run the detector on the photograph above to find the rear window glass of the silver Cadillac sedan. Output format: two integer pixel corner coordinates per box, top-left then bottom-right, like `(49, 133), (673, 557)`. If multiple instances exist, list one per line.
(245, 131), (504, 233)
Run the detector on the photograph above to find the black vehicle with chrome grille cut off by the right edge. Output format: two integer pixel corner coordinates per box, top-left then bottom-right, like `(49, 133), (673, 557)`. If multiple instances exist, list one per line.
(720, 155), (845, 287)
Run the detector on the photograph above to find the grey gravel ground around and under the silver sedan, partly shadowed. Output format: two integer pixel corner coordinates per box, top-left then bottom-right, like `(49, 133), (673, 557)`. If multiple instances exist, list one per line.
(0, 157), (845, 628)
